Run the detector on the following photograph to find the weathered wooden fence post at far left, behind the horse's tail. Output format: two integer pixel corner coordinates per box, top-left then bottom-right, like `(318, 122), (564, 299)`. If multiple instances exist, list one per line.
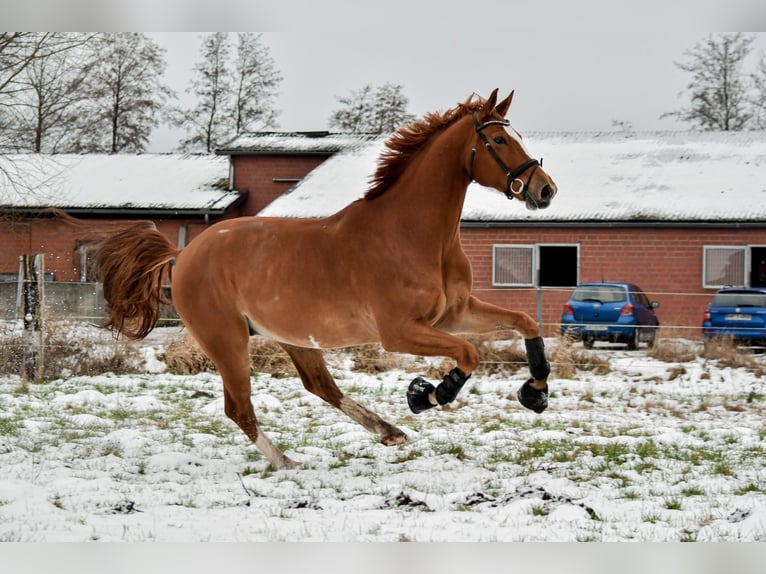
(19, 253), (45, 381)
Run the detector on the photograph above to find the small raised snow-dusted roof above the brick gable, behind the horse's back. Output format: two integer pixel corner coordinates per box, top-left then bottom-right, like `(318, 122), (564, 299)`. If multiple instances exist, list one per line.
(216, 131), (375, 155)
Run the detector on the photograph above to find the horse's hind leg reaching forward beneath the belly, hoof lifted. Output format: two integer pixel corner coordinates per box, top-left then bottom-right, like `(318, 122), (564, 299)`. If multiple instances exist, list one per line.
(280, 343), (407, 446)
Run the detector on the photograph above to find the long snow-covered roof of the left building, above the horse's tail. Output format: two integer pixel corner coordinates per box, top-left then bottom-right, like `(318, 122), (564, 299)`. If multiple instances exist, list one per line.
(0, 154), (240, 213)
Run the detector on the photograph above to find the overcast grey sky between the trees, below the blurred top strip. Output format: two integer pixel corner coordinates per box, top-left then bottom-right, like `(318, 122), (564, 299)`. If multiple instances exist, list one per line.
(151, 27), (766, 151)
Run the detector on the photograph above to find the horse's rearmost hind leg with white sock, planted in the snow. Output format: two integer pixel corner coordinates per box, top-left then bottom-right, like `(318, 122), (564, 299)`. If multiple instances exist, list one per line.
(183, 323), (297, 468)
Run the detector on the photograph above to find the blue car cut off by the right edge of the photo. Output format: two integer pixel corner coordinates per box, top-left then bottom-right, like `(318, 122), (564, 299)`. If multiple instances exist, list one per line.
(702, 287), (766, 347)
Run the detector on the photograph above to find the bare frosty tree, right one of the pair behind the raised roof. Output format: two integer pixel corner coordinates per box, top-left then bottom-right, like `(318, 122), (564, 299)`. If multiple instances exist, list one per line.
(232, 32), (282, 135)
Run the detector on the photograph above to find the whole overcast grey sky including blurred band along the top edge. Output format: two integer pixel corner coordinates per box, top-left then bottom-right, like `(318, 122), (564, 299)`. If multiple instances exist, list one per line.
(6, 0), (766, 151)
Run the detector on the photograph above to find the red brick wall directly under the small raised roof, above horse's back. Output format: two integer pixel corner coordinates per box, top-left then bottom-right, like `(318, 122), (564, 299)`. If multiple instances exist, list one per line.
(231, 154), (329, 215)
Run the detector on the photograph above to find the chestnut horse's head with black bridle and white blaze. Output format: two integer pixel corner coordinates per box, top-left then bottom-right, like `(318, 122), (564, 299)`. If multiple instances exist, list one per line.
(469, 89), (557, 209)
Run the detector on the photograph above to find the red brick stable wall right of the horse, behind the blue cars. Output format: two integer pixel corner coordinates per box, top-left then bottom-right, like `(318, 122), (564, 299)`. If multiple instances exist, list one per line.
(461, 227), (766, 337)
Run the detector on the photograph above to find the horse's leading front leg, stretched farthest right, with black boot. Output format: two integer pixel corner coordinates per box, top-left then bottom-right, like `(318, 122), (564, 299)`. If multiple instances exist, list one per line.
(440, 296), (551, 413)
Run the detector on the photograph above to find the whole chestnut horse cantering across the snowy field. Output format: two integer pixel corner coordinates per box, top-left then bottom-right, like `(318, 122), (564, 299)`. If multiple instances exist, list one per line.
(96, 90), (556, 468)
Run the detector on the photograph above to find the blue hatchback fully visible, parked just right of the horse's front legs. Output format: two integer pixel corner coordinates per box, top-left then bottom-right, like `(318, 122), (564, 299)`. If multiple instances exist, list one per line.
(561, 282), (660, 350)
